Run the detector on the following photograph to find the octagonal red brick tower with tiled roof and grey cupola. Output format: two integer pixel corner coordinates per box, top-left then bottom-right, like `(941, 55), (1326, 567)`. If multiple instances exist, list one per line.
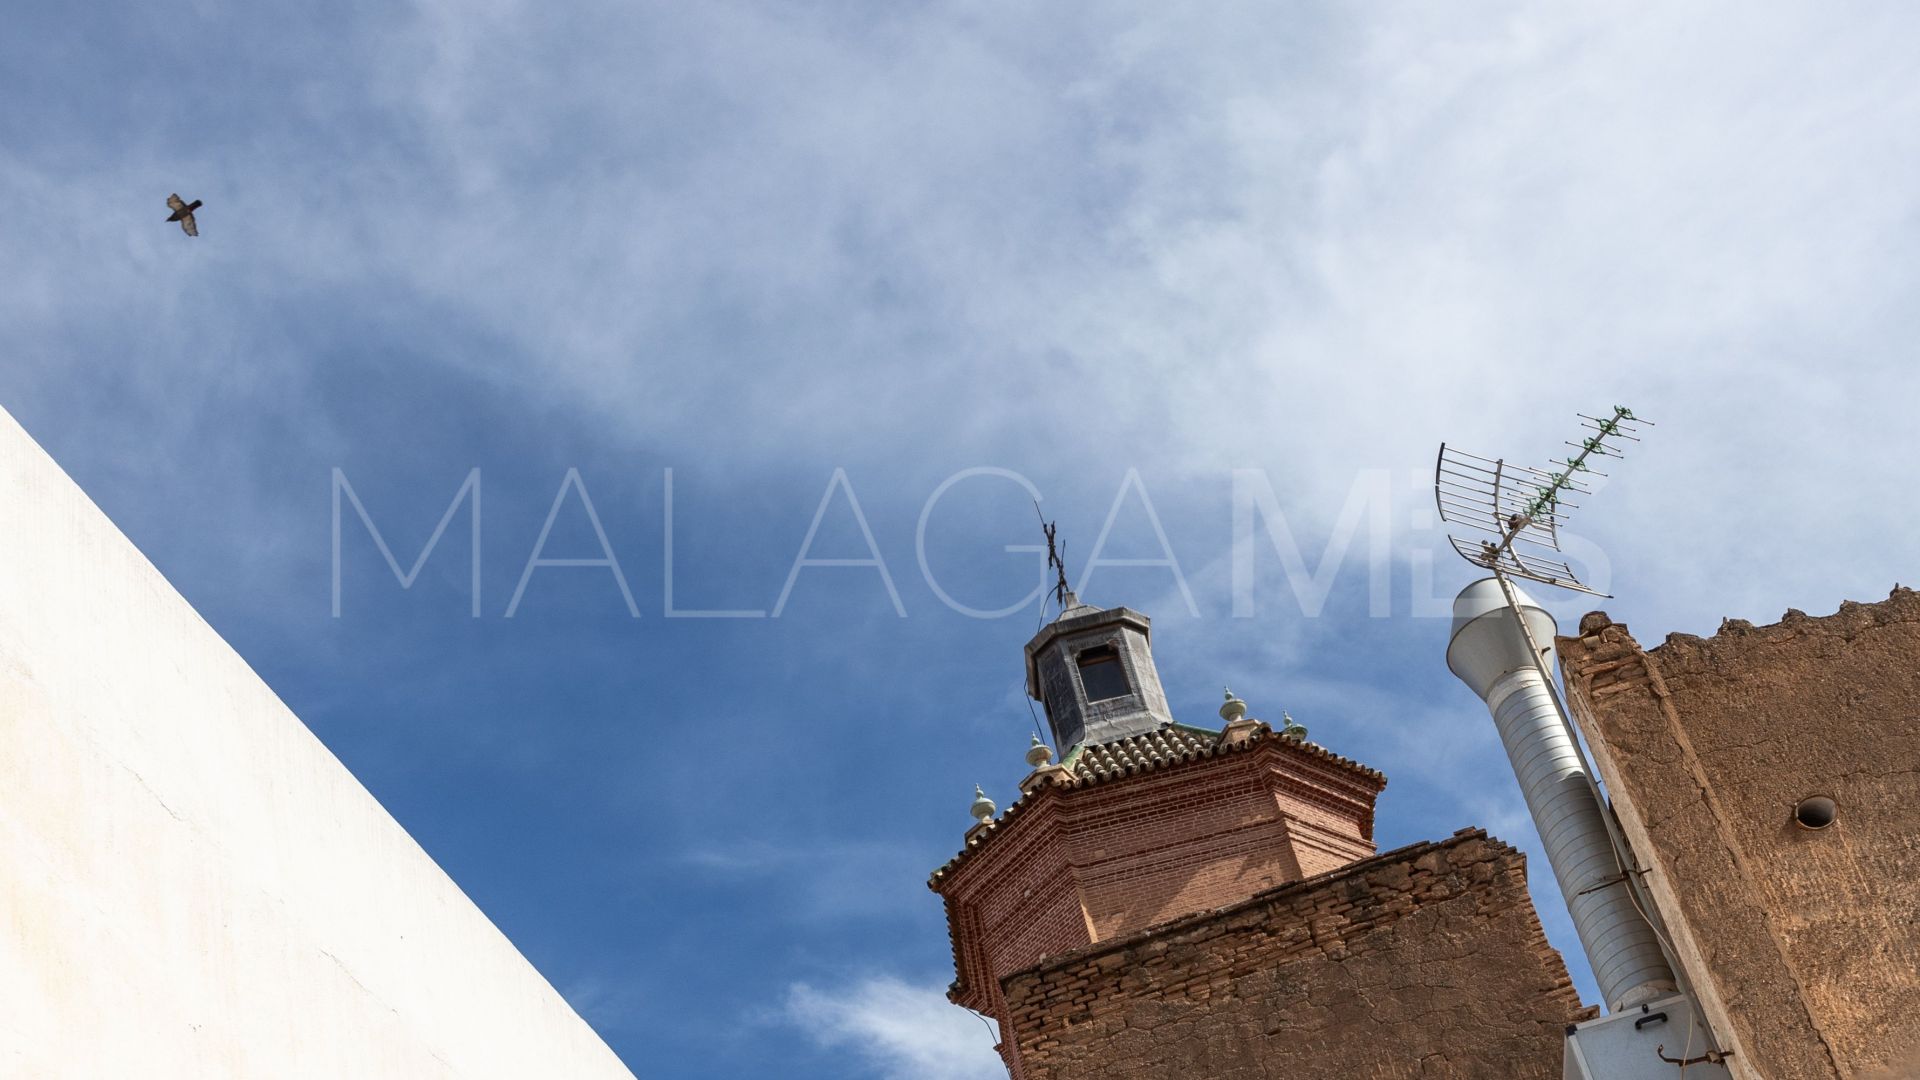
(929, 594), (1386, 1080)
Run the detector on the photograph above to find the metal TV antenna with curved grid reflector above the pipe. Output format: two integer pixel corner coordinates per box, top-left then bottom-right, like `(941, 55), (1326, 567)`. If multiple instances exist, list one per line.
(1434, 405), (1653, 596)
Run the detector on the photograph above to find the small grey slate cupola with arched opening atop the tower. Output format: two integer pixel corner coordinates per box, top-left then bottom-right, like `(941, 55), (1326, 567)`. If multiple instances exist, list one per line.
(1027, 592), (1173, 759)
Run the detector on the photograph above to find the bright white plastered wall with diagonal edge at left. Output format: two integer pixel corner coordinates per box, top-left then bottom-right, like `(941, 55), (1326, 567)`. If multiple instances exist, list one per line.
(0, 403), (632, 1080)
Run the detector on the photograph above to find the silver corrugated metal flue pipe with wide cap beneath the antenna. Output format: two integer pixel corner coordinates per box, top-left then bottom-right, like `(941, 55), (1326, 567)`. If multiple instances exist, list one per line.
(1446, 578), (1674, 1011)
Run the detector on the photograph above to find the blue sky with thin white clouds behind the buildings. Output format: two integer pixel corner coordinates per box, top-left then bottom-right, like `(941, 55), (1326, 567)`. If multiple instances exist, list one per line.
(0, 0), (1920, 1080)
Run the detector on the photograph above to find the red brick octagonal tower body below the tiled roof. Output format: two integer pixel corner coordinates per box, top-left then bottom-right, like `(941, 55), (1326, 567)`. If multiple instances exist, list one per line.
(929, 732), (1384, 1076)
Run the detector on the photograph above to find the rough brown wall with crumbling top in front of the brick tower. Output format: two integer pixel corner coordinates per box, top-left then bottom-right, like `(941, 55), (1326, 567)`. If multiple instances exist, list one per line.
(1004, 830), (1586, 1080)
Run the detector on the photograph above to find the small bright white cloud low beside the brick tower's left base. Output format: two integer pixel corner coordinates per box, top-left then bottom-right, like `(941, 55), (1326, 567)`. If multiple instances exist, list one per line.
(785, 976), (1006, 1080)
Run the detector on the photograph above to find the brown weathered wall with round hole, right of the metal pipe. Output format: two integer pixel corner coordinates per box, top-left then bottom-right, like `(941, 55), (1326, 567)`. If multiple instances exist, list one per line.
(1559, 590), (1920, 1080)
